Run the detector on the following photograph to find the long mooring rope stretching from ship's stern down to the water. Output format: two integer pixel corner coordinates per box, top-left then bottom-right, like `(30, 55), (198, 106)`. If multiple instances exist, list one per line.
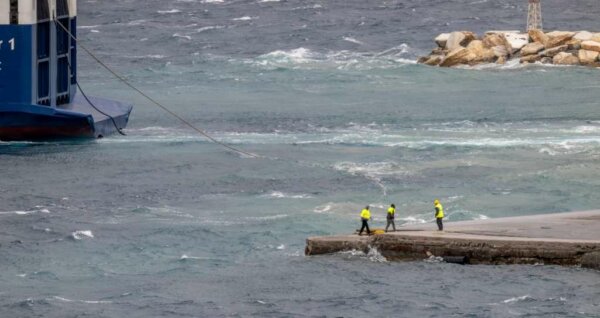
(54, 19), (260, 158)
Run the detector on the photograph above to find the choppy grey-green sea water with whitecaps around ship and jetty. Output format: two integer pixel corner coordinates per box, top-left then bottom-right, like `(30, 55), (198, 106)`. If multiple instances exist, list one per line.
(0, 0), (600, 318)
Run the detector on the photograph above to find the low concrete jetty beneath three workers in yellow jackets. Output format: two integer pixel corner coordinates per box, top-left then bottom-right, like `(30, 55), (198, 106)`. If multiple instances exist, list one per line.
(305, 210), (600, 269)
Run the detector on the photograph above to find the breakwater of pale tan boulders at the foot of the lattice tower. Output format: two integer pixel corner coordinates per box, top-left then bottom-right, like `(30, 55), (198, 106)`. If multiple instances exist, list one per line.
(418, 30), (600, 67)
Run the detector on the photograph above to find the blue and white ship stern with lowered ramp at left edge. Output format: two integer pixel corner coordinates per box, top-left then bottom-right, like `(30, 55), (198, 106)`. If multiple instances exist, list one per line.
(0, 4), (132, 141)
